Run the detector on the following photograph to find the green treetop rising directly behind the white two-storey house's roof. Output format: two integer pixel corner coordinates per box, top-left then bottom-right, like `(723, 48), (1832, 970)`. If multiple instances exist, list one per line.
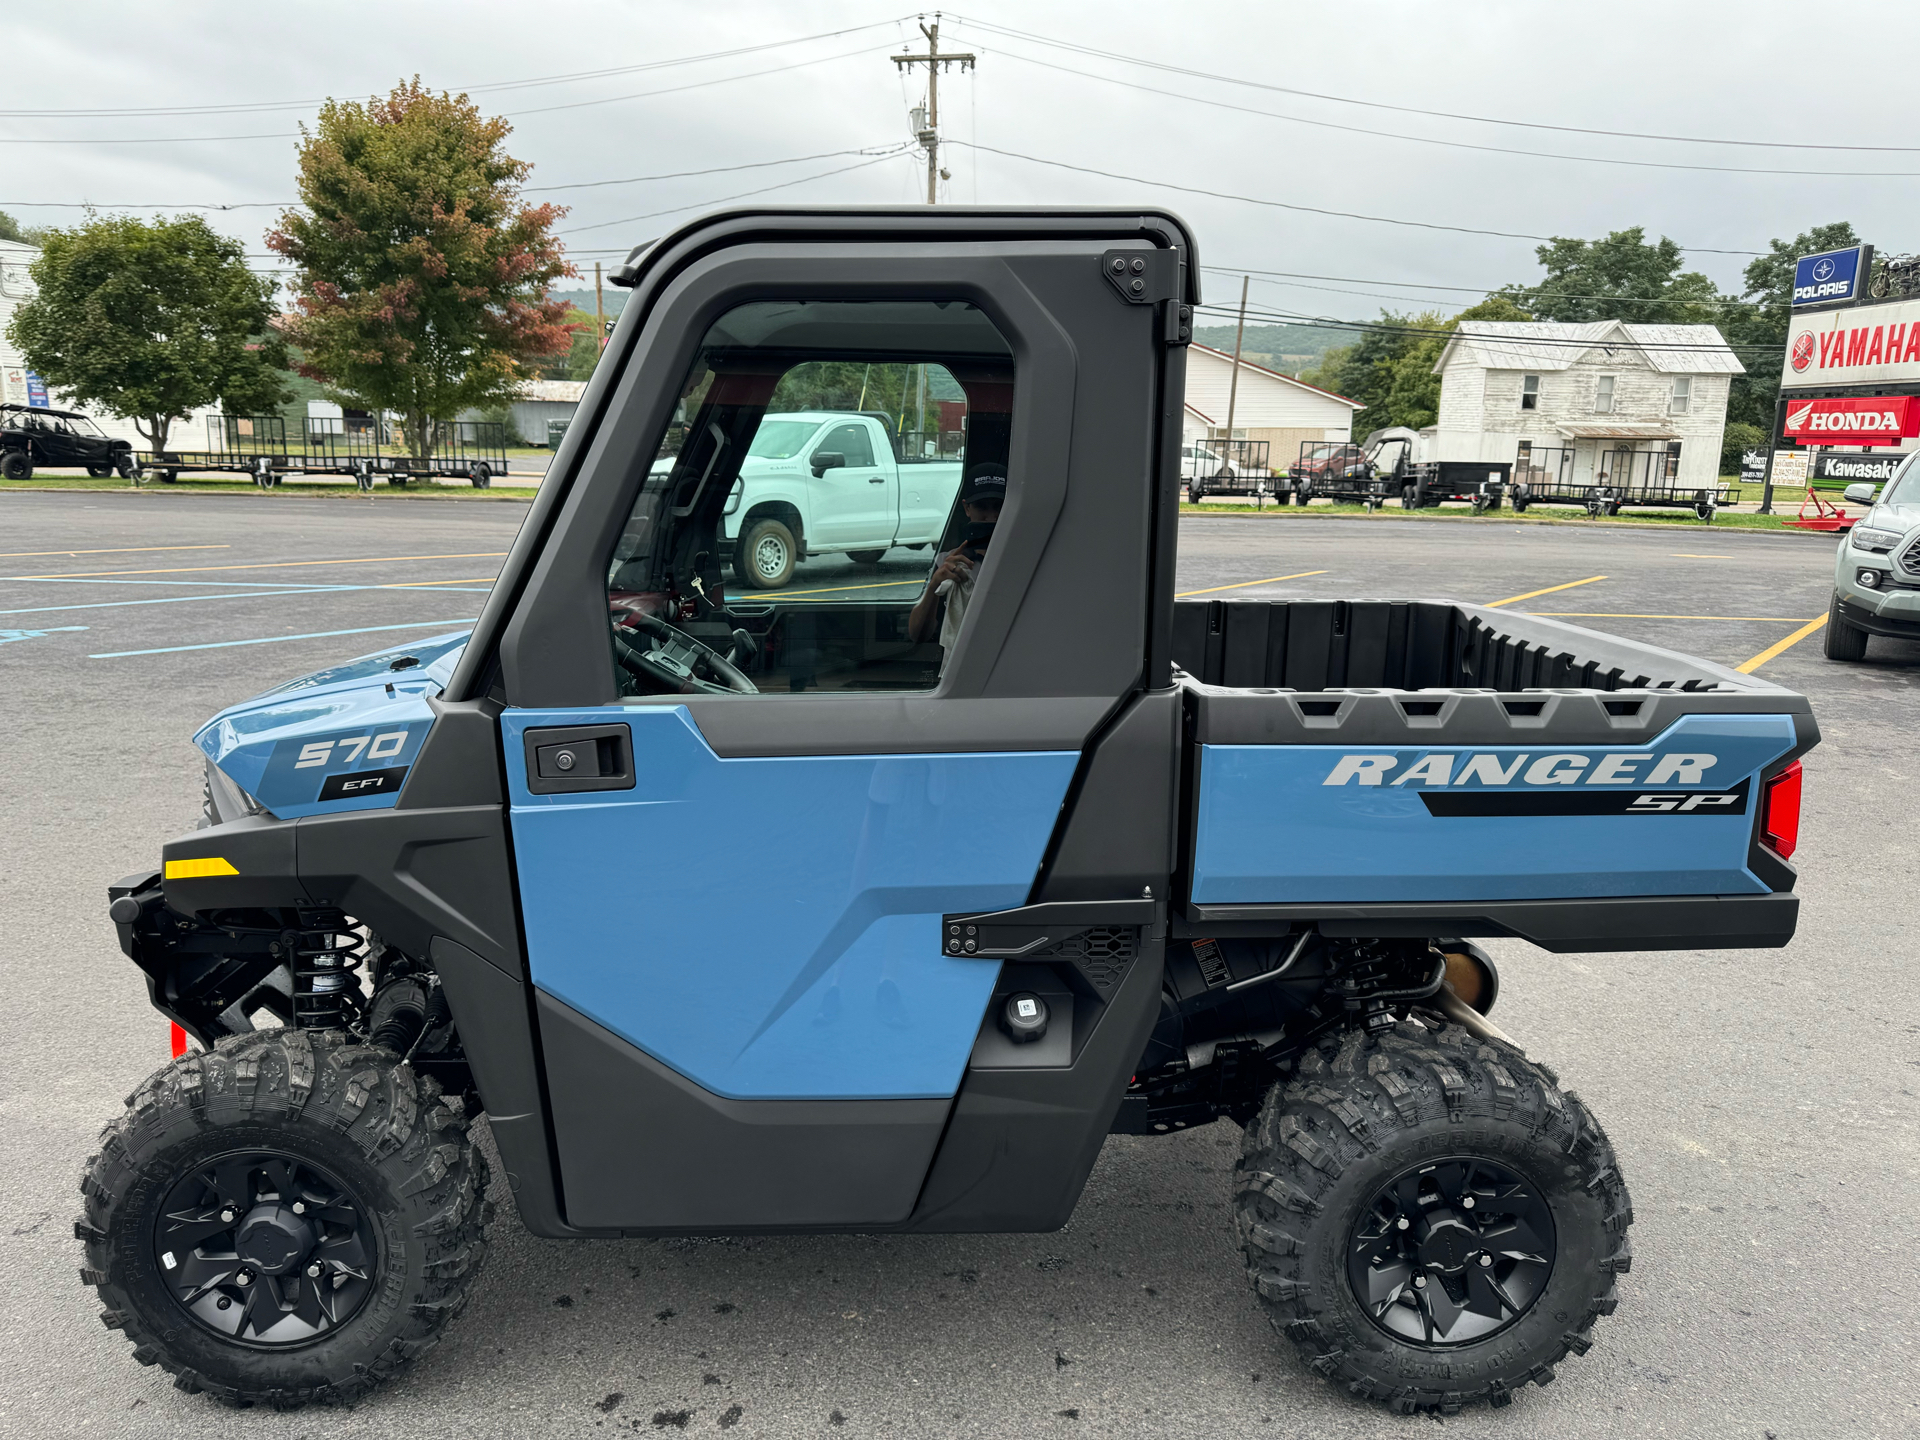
(1496, 225), (1723, 325)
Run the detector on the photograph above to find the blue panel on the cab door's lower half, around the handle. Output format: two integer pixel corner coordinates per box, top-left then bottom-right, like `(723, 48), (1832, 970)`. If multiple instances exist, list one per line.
(501, 705), (1076, 1099)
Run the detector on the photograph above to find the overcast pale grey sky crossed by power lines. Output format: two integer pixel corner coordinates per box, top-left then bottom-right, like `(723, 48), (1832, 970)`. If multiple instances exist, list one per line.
(0, 0), (1921, 326)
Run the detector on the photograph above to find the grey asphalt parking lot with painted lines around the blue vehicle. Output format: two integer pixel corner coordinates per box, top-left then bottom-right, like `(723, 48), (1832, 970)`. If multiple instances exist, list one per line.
(0, 492), (1921, 1437)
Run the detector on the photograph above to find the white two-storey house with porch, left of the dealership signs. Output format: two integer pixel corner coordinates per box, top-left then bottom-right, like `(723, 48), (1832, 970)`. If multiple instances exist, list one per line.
(1427, 321), (1742, 490)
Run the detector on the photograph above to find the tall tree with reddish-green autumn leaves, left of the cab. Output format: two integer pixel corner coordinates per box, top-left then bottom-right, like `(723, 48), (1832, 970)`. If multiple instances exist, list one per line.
(267, 77), (576, 457)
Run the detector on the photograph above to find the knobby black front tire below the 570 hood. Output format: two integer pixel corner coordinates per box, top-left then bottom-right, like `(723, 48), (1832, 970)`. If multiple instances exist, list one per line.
(73, 1030), (492, 1408)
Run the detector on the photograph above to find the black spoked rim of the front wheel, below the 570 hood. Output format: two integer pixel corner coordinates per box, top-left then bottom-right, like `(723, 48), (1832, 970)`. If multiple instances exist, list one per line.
(154, 1151), (378, 1349)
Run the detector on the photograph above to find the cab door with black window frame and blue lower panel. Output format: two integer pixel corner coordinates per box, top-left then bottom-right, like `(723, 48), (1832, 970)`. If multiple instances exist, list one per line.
(480, 217), (1179, 1230)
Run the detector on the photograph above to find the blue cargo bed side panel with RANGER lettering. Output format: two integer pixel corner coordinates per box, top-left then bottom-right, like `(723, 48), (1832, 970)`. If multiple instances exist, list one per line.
(1193, 715), (1794, 905)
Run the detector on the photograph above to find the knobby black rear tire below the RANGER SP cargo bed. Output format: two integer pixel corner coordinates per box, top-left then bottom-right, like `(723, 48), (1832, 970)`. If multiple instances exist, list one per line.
(1233, 1022), (1633, 1414)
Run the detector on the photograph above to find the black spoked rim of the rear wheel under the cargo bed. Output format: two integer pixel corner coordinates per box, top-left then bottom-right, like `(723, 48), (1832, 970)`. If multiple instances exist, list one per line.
(1347, 1157), (1554, 1347)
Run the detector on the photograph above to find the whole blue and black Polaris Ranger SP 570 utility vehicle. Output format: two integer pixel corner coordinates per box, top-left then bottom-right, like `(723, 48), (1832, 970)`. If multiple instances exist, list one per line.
(77, 208), (1817, 1410)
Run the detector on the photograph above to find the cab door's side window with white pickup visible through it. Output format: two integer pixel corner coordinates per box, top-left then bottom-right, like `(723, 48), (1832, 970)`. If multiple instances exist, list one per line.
(607, 300), (1014, 697)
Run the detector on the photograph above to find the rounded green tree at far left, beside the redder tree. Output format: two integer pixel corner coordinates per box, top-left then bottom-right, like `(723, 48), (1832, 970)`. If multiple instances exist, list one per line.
(8, 215), (286, 450)
